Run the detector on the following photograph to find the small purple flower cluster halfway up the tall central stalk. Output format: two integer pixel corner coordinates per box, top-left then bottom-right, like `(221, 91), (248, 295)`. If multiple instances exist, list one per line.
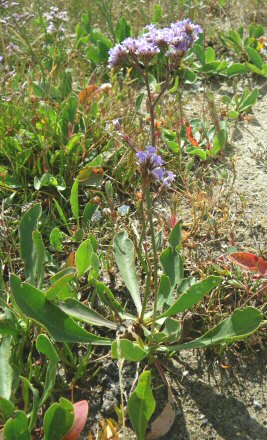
(136, 145), (175, 186)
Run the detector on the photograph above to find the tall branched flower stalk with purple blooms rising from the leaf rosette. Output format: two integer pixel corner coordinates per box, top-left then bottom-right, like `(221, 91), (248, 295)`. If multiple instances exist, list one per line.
(109, 19), (202, 333)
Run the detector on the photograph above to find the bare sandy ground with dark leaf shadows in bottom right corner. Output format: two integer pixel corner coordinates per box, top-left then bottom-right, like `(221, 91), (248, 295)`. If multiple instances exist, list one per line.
(164, 351), (267, 440)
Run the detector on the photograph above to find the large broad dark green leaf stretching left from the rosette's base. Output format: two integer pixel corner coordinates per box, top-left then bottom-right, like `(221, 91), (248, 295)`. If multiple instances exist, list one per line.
(10, 274), (111, 345)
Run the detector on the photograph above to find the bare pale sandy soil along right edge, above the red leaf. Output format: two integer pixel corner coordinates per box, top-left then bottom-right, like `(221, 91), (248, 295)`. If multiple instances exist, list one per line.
(233, 84), (267, 252)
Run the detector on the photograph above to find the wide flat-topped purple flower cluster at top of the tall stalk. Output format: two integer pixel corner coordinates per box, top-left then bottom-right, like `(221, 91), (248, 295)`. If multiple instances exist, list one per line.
(109, 19), (202, 67)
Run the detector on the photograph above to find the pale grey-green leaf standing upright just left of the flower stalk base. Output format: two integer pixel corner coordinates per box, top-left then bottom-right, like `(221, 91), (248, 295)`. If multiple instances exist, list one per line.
(114, 231), (142, 314)
